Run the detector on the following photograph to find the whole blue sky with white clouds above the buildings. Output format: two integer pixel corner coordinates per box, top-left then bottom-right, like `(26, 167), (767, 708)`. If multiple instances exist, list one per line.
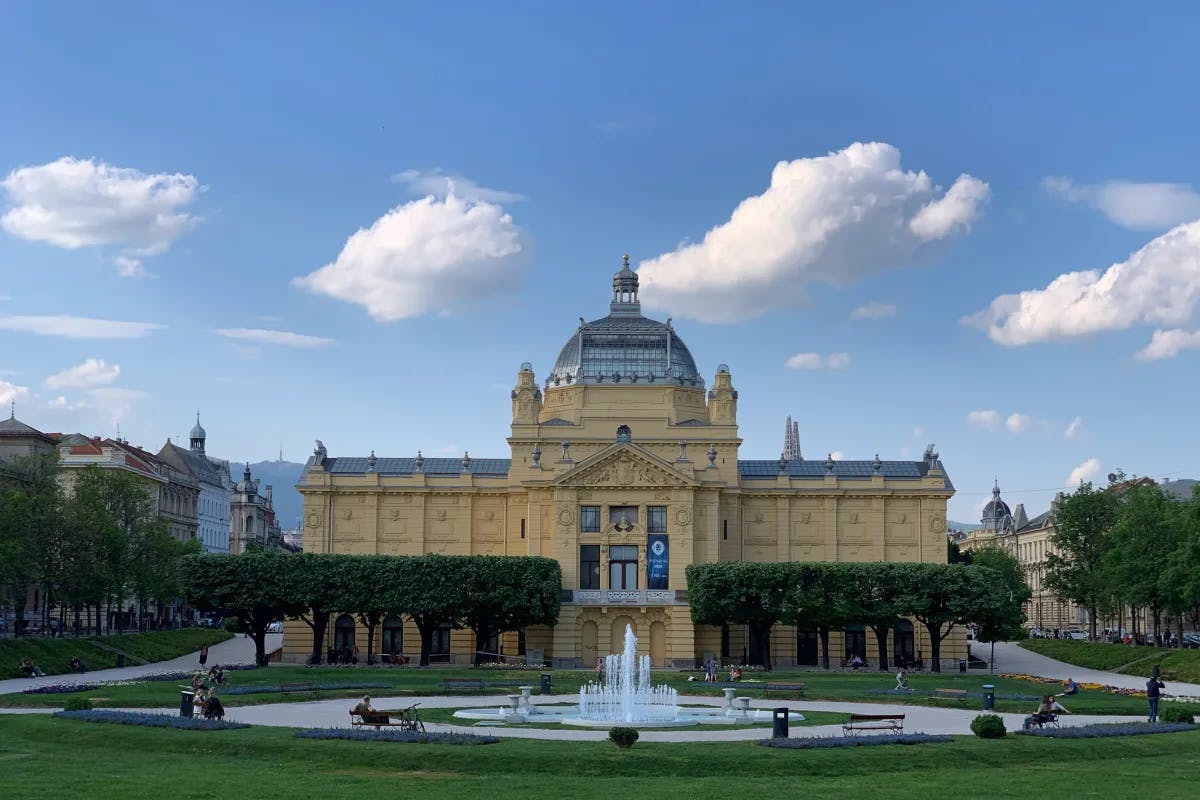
(0, 1), (1200, 522)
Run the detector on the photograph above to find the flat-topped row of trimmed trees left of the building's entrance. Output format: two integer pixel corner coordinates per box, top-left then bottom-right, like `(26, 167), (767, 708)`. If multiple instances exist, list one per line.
(184, 552), (563, 666)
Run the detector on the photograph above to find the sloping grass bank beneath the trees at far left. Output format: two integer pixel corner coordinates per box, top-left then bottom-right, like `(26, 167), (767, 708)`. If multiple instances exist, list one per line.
(0, 627), (233, 678)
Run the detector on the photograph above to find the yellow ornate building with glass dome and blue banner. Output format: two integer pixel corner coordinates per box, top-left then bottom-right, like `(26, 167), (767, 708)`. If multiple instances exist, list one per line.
(295, 258), (965, 667)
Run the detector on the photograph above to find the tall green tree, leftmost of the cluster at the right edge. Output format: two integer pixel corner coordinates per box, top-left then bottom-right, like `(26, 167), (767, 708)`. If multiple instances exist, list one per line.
(1046, 483), (1117, 639)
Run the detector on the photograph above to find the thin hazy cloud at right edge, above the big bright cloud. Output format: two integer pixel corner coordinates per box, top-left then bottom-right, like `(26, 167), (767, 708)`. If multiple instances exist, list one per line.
(1042, 176), (1200, 230)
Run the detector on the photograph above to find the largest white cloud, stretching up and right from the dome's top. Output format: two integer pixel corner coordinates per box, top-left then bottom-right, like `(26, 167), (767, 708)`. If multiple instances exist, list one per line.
(638, 142), (988, 321)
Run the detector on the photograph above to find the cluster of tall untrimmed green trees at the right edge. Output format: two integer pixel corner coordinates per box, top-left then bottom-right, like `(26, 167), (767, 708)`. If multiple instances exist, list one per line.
(1045, 474), (1200, 639)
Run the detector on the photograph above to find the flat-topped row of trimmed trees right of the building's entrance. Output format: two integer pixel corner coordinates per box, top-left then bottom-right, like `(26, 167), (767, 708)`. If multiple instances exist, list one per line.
(688, 561), (1030, 672)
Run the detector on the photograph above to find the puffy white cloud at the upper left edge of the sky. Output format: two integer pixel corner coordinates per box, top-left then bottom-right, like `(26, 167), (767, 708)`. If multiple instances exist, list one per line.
(0, 156), (204, 275)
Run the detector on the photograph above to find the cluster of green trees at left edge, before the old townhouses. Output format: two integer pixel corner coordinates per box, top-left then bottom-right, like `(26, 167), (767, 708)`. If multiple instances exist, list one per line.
(0, 455), (199, 636)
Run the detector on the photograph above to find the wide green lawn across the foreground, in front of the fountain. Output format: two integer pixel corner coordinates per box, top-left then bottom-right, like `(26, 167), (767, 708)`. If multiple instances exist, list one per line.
(0, 716), (1200, 800)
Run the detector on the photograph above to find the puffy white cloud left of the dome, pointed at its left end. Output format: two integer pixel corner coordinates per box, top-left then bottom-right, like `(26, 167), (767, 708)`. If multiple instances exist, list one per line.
(292, 194), (527, 321)
